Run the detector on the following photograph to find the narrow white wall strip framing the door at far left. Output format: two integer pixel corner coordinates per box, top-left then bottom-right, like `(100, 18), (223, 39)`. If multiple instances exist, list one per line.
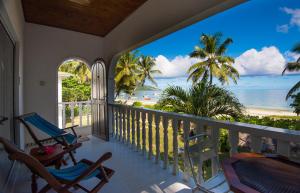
(0, 0), (25, 147)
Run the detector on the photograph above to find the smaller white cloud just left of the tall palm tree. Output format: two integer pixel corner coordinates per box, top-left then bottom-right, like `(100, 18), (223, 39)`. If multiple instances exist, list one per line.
(155, 55), (200, 77)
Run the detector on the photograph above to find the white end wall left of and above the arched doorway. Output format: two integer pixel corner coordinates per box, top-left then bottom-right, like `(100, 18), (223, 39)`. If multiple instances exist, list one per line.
(24, 23), (103, 141)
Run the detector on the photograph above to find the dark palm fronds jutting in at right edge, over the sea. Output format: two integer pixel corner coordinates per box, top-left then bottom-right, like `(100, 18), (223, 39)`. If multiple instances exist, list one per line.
(282, 43), (300, 100)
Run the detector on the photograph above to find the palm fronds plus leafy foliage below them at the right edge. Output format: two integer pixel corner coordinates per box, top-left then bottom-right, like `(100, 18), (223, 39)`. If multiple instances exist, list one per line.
(282, 43), (300, 115)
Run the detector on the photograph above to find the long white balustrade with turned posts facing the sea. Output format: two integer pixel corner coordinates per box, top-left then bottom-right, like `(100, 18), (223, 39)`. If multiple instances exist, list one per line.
(109, 104), (300, 181)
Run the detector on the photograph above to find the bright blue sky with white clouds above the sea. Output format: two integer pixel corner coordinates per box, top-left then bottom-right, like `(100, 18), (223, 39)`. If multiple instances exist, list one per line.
(138, 0), (300, 77)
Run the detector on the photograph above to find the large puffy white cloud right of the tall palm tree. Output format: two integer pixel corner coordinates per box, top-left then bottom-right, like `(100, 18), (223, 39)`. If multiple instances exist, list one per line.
(234, 46), (286, 75)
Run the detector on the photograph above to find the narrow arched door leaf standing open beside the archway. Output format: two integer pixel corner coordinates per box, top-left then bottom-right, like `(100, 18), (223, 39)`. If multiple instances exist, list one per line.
(91, 59), (109, 140)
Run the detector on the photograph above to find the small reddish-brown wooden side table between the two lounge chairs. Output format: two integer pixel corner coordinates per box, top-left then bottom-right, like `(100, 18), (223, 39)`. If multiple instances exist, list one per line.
(30, 144), (65, 193)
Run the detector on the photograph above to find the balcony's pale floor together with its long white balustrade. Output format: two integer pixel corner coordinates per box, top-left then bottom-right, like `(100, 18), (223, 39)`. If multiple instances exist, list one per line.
(4, 104), (300, 193)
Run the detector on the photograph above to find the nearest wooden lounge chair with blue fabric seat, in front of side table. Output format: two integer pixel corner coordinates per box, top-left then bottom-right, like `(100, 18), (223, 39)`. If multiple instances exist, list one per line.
(0, 137), (114, 193)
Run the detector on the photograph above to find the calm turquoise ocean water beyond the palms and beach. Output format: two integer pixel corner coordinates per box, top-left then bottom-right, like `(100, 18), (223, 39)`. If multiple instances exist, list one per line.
(127, 75), (300, 110)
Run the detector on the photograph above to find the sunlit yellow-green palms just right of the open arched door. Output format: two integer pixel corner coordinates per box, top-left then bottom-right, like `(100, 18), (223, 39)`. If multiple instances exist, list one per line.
(115, 52), (161, 96)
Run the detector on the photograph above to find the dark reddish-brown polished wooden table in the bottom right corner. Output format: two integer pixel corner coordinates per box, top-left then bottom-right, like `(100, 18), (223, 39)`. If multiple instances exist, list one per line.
(222, 153), (300, 193)
